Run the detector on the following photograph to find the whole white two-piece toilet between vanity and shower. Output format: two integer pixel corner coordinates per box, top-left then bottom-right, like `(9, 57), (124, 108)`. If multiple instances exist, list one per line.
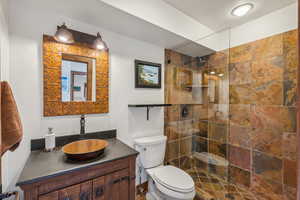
(135, 136), (195, 200)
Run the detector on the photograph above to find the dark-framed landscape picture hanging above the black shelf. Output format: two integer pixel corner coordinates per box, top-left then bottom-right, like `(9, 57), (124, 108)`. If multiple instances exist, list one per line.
(135, 60), (161, 89)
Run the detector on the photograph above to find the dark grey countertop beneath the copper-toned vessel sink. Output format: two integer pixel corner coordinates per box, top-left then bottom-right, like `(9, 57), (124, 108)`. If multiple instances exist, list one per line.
(17, 139), (138, 186)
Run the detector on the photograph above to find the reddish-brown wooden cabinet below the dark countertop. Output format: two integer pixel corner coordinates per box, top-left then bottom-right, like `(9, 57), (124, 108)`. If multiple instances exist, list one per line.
(21, 156), (135, 200)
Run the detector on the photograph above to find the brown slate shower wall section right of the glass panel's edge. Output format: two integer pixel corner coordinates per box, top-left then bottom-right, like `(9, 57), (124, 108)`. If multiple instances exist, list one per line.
(228, 30), (298, 200)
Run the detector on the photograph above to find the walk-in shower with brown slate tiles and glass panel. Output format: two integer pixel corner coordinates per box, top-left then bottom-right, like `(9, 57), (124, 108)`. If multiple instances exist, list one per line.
(165, 30), (298, 200)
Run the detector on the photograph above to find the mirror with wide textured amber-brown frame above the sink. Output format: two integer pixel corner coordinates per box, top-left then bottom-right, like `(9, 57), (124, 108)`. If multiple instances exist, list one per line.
(43, 30), (109, 116)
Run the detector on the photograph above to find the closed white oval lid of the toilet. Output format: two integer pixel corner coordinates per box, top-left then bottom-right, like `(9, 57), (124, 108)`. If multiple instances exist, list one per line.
(153, 166), (195, 192)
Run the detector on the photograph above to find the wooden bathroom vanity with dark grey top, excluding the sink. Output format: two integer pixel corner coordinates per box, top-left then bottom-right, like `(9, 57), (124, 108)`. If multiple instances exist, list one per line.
(17, 131), (138, 200)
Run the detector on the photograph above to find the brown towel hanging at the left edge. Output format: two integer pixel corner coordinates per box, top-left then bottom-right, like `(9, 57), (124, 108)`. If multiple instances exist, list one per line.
(1, 81), (23, 155)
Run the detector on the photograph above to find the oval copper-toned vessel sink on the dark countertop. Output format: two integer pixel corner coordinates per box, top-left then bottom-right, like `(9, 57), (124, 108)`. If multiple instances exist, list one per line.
(62, 139), (108, 160)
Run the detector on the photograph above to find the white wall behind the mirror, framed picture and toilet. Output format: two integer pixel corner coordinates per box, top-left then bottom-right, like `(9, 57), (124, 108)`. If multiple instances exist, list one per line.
(4, 0), (164, 192)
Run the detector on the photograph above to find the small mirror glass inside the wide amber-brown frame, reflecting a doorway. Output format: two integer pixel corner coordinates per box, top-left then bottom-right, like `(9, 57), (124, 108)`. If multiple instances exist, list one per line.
(61, 55), (96, 102)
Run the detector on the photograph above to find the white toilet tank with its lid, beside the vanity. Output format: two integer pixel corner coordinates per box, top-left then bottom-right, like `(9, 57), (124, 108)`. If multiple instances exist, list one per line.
(134, 136), (167, 169)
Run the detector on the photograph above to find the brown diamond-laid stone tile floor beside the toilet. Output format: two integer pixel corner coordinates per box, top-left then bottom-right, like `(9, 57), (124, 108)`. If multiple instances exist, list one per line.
(136, 168), (257, 200)
